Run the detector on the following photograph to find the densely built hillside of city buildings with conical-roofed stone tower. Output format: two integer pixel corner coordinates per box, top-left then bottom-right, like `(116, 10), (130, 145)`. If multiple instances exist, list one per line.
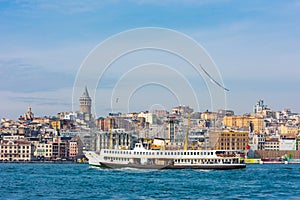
(0, 88), (300, 162)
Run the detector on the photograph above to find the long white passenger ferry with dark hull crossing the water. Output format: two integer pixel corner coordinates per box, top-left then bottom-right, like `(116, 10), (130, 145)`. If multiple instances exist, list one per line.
(85, 143), (246, 170)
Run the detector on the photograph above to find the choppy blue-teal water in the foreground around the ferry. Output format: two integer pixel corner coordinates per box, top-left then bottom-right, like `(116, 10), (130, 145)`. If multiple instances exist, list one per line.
(0, 164), (300, 199)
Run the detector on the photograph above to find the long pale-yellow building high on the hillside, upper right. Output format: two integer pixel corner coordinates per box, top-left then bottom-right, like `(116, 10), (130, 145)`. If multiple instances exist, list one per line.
(223, 115), (265, 133)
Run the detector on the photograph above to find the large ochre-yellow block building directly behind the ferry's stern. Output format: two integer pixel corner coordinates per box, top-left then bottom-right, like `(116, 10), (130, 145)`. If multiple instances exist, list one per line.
(210, 130), (249, 150)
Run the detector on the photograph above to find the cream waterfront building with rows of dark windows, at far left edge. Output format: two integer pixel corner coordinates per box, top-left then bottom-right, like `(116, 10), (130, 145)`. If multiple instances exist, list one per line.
(0, 140), (34, 162)
